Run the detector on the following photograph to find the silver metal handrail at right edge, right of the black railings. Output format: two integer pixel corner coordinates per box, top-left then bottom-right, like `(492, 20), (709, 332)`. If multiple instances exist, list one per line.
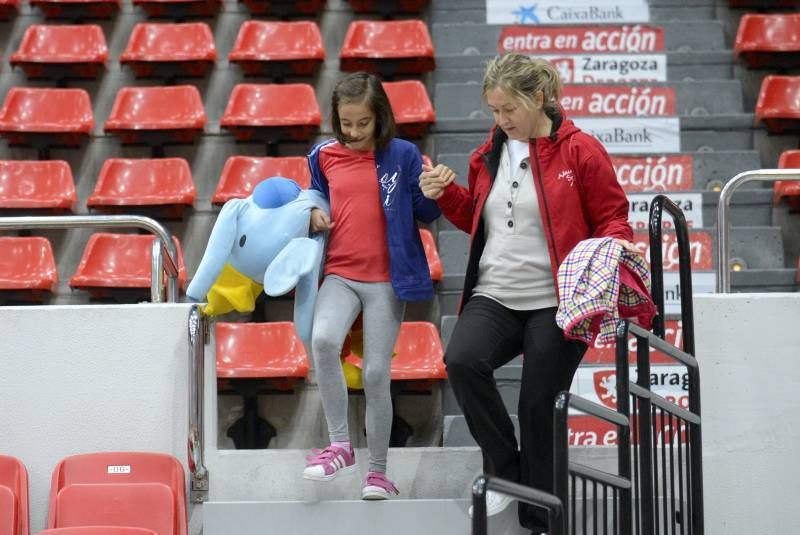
(717, 169), (800, 293)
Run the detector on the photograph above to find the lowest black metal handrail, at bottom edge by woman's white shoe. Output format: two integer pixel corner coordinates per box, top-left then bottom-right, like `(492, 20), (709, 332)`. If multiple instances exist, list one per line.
(472, 474), (567, 535)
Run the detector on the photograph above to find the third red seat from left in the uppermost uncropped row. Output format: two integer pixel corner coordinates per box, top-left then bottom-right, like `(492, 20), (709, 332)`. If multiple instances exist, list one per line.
(228, 20), (325, 78)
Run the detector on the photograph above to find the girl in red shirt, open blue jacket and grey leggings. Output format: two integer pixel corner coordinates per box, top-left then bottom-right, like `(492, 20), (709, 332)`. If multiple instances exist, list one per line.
(303, 72), (440, 500)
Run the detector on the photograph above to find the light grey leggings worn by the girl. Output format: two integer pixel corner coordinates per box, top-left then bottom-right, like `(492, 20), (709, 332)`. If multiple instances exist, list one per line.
(311, 275), (405, 472)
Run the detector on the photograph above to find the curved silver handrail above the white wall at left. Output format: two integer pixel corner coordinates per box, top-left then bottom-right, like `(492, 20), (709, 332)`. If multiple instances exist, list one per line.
(0, 215), (178, 303)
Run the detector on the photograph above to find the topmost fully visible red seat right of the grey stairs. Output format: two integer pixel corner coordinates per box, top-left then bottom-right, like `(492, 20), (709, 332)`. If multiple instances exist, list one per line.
(733, 13), (800, 69)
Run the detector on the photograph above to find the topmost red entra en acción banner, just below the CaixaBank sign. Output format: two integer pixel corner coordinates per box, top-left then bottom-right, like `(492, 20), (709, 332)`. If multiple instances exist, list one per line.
(498, 24), (664, 54)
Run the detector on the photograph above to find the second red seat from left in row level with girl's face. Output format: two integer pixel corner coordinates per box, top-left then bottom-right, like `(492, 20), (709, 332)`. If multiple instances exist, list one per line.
(104, 85), (206, 147)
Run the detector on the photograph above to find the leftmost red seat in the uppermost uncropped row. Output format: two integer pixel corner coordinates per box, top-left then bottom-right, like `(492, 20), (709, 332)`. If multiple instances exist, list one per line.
(9, 24), (108, 79)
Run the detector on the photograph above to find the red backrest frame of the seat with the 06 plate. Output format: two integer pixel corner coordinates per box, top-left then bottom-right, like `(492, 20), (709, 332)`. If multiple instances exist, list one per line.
(48, 452), (186, 535)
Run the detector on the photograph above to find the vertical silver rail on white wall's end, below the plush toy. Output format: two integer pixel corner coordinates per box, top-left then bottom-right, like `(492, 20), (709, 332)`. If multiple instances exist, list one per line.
(189, 305), (208, 503)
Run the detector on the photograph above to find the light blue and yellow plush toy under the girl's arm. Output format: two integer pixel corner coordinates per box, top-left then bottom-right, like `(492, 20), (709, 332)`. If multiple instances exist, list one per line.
(186, 177), (330, 343)
